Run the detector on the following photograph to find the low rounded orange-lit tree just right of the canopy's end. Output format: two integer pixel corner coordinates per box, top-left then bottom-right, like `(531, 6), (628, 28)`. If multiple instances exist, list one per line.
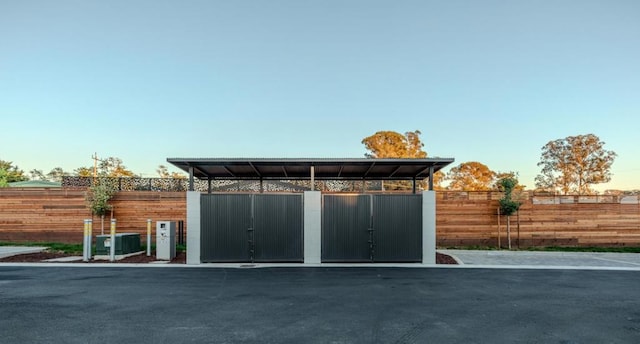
(447, 161), (496, 191)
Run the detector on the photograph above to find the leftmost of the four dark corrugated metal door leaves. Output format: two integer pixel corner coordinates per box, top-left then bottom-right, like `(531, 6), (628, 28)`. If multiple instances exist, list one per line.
(200, 194), (252, 263)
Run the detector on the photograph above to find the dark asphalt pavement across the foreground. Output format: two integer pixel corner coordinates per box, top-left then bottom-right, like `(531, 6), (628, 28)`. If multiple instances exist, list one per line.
(0, 266), (640, 343)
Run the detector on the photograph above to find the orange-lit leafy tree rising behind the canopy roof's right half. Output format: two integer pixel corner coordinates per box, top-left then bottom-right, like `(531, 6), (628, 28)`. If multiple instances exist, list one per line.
(362, 130), (427, 190)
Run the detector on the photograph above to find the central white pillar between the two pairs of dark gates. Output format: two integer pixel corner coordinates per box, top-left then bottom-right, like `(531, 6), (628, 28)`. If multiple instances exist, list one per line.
(304, 191), (322, 264)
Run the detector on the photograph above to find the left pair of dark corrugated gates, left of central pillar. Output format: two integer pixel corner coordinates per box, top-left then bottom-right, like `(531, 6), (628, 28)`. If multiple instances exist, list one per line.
(200, 194), (304, 263)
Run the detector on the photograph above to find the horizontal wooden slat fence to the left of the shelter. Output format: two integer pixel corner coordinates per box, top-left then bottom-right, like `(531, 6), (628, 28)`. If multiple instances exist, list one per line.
(0, 188), (186, 243)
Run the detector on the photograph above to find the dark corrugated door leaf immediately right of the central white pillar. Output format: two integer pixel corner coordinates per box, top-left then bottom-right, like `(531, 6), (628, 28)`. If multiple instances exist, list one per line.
(322, 195), (371, 262)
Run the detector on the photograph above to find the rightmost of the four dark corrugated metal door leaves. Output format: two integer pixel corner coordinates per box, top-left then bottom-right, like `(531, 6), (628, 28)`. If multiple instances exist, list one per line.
(373, 195), (422, 262)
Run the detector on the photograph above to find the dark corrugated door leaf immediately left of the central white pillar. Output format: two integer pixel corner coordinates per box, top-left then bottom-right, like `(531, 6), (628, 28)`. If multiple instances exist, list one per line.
(253, 194), (304, 262)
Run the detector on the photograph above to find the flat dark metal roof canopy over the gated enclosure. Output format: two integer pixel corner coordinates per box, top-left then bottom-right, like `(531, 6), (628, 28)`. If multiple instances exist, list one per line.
(167, 158), (454, 190)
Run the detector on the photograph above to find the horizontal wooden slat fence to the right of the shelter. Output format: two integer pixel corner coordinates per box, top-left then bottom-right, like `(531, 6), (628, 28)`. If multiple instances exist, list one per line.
(436, 191), (640, 247)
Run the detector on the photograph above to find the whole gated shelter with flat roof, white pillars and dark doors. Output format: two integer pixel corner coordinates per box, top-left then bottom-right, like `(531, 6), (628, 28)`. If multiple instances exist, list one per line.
(167, 158), (454, 264)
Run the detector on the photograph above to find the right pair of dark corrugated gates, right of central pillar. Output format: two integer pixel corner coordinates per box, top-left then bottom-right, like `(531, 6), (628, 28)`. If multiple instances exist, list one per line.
(322, 194), (422, 262)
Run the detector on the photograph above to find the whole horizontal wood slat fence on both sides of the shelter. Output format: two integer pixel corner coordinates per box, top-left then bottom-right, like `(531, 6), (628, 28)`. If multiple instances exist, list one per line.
(0, 188), (640, 247)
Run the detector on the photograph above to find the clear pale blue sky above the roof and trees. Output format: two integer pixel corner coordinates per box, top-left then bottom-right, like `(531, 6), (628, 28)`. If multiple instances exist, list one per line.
(0, 0), (640, 190)
